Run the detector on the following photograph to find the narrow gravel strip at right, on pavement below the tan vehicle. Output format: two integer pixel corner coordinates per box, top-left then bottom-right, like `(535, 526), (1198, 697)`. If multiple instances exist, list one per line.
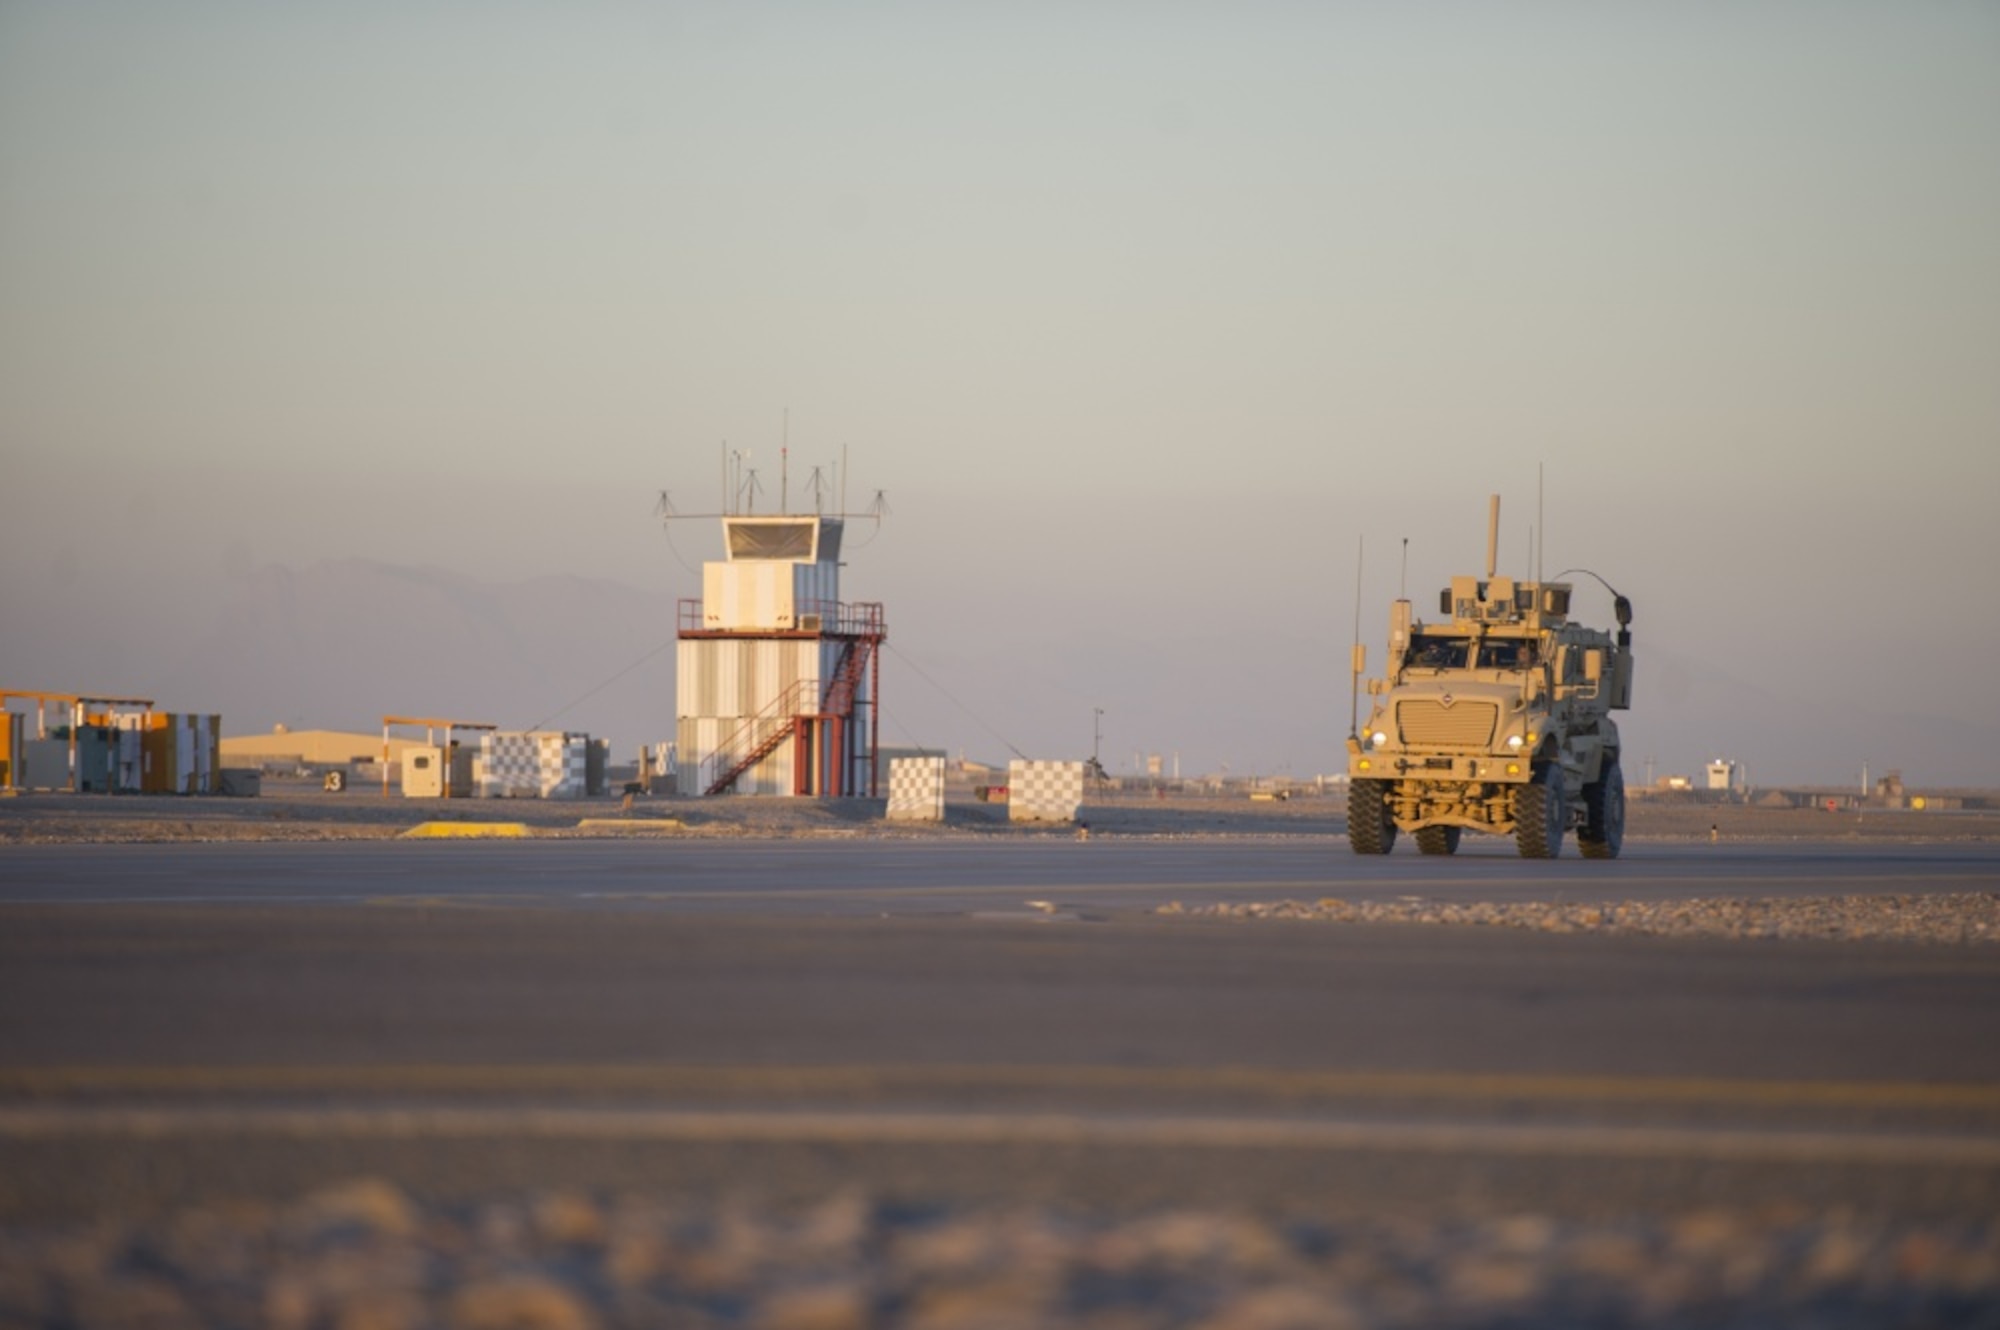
(1158, 892), (2000, 942)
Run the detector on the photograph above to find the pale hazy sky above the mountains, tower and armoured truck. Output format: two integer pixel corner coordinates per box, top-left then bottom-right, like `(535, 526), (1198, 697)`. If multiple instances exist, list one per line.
(0, 0), (2000, 786)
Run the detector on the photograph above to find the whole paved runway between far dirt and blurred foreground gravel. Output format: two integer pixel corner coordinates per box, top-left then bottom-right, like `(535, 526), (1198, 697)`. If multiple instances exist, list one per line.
(0, 838), (2000, 1216)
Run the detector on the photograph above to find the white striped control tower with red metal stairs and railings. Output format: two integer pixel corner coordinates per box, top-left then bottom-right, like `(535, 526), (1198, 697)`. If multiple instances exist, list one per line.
(674, 514), (888, 798)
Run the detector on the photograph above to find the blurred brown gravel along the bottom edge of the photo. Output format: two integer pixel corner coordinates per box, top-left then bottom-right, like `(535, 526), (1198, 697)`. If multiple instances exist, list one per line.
(0, 1178), (2000, 1330)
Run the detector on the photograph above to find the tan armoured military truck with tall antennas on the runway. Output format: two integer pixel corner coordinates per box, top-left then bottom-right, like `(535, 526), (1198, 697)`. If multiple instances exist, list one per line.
(1348, 494), (1632, 858)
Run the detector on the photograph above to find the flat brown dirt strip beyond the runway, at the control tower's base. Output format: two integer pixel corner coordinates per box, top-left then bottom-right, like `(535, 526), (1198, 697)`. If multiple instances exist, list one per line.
(0, 780), (2000, 844)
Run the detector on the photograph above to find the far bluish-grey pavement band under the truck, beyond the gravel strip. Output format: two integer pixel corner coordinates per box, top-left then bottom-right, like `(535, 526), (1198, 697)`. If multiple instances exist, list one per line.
(0, 836), (2000, 916)
